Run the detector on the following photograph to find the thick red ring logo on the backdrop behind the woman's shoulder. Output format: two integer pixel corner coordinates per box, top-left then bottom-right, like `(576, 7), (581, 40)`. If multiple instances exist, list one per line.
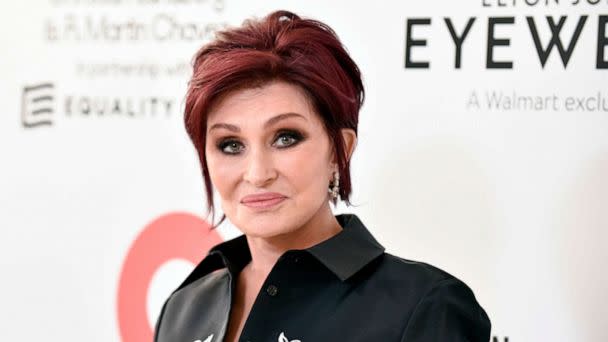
(117, 213), (222, 342)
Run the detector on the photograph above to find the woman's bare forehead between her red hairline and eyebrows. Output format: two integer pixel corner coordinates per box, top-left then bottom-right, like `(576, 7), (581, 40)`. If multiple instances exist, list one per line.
(207, 81), (321, 127)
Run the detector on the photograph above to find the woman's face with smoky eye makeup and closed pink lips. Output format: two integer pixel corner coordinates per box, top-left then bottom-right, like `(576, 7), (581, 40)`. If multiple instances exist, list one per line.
(205, 81), (335, 238)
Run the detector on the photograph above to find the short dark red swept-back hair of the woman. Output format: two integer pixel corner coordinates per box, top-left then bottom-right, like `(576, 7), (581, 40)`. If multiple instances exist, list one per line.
(184, 11), (365, 226)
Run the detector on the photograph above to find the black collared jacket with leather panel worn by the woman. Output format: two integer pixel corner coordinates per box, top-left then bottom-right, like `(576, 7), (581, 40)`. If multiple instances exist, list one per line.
(154, 214), (490, 342)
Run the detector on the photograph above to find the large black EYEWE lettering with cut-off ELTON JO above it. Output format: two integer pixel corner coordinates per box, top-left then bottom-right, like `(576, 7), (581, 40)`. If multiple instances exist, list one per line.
(404, 0), (608, 70)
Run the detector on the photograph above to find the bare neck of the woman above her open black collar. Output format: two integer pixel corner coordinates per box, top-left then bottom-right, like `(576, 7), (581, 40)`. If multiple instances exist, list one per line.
(246, 204), (342, 279)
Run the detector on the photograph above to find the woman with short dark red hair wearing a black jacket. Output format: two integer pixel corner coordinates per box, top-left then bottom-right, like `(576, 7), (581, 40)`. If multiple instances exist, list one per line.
(155, 11), (490, 342)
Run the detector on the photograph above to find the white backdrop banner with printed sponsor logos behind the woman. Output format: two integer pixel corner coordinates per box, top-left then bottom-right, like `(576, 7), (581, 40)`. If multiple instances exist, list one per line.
(0, 0), (608, 342)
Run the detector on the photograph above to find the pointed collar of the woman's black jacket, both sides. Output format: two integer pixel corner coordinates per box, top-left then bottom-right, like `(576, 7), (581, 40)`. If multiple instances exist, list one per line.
(178, 214), (384, 290)
